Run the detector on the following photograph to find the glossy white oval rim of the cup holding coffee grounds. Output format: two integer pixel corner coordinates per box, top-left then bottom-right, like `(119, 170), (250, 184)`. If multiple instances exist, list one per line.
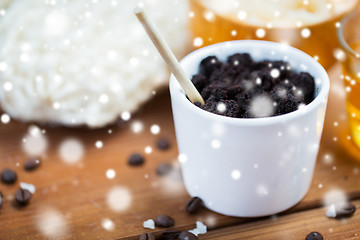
(169, 40), (330, 126)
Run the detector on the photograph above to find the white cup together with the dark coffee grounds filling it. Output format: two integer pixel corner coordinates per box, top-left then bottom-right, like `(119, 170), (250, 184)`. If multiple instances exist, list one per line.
(170, 40), (330, 217)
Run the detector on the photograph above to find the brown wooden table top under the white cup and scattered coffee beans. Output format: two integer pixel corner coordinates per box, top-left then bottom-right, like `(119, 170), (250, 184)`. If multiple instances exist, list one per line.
(0, 64), (360, 240)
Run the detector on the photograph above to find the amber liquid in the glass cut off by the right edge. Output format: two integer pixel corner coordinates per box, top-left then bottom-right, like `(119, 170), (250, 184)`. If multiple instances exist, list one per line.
(343, 41), (360, 148)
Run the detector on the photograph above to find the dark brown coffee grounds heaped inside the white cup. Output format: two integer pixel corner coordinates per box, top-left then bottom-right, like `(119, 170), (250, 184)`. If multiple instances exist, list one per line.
(192, 53), (315, 118)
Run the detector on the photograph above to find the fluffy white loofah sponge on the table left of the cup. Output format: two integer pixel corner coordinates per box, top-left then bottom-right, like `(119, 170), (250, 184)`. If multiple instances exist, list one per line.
(0, 0), (189, 127)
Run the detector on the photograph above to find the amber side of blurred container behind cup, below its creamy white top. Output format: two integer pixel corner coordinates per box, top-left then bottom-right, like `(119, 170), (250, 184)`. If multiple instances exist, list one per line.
(190, 0), (358, 68)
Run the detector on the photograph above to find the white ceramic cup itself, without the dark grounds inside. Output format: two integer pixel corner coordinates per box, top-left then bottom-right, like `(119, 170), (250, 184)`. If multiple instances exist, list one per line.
(170, 40), (330, 217)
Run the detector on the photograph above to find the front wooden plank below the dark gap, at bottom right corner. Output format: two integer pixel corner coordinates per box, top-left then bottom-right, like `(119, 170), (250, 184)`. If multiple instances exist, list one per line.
(202, 200), (360, 240)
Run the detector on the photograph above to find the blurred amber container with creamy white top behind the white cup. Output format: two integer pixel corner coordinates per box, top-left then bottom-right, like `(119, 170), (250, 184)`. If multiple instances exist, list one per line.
(190, 0), (359, 68)
